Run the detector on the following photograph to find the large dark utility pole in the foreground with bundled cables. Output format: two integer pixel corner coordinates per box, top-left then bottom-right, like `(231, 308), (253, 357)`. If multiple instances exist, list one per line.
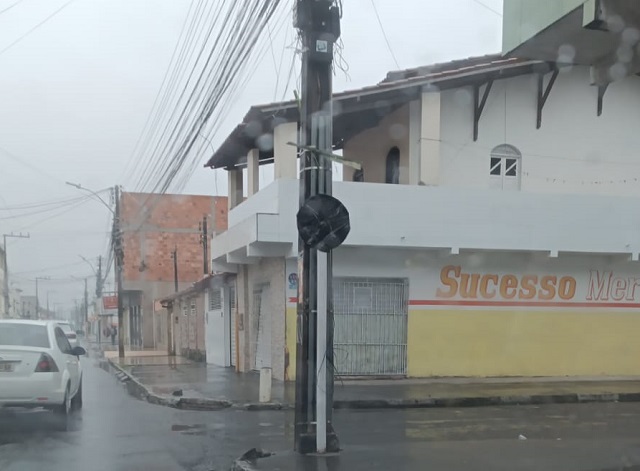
(294, 0), (341, 454)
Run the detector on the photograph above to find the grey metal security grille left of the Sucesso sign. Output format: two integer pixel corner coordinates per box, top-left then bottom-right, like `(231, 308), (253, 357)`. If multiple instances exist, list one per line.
(333, 278), (409, 376)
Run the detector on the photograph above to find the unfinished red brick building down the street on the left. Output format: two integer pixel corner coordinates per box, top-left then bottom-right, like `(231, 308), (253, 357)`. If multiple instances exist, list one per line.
(120, 192), (227, 348)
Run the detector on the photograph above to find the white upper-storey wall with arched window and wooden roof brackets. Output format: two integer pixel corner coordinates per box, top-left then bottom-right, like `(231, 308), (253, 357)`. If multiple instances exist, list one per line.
(440, 67), (640, 196)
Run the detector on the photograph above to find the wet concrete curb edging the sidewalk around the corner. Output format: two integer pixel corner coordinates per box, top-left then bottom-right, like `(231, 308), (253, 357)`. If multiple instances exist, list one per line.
(100, 359), (640, 411)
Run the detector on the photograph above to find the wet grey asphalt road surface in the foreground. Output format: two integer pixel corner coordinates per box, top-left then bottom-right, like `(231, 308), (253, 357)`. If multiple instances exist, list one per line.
(0, 359), (640, 471)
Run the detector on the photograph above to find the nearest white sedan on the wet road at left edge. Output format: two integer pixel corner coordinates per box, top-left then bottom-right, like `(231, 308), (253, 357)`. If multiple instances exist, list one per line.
(0, 319), (86, 416)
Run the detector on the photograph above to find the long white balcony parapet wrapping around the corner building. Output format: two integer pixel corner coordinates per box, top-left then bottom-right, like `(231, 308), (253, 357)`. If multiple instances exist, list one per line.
(212, 180), (640, 263)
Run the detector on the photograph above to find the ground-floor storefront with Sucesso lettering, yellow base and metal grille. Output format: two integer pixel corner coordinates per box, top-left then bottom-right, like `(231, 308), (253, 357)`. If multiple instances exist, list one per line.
(287, 248), (640, 379)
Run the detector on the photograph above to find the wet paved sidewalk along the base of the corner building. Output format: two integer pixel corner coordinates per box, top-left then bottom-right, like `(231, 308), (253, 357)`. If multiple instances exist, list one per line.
(99, 351), (640, 409)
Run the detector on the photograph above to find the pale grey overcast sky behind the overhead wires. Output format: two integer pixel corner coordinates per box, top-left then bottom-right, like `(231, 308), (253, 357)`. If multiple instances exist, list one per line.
(0, 0), (502, 312)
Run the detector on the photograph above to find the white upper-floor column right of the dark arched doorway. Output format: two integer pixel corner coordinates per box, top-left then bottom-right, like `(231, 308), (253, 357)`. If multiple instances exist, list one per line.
(420, 92), (440, 185)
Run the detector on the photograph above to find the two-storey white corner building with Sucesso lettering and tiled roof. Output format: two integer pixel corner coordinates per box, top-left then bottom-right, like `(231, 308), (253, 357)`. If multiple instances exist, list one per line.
(209, 56), (640, 379)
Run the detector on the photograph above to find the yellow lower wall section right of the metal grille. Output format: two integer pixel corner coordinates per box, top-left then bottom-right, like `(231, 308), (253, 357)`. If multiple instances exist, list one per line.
(408, 309), (640, 377)
